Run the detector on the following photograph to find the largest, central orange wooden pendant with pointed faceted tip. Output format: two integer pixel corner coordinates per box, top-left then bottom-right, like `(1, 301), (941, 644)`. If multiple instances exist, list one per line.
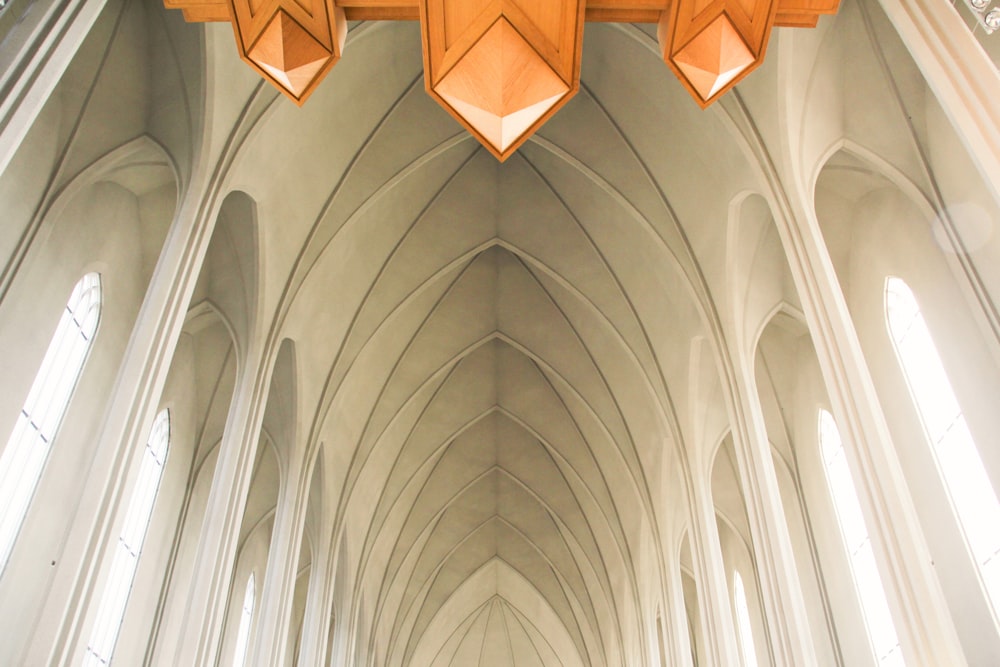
(421, 0), (584, 161)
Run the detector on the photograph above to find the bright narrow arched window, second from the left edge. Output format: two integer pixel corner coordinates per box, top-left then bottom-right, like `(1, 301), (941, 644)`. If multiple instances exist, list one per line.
(83, 410), (170, 667)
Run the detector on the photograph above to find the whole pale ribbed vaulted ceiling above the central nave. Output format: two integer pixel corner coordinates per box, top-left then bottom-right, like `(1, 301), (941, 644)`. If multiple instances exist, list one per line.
(172, 3), (960, 667)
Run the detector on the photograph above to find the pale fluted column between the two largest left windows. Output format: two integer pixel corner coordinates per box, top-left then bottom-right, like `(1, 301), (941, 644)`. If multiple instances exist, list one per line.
(18, 164), (223, 665)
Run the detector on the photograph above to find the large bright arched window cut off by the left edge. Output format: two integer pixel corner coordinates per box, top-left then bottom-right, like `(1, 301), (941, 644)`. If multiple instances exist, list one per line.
(0, 273), (101, 568)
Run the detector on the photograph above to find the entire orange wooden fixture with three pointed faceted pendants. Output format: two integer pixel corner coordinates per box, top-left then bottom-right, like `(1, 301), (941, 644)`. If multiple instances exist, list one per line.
(163, 0), (840, 161)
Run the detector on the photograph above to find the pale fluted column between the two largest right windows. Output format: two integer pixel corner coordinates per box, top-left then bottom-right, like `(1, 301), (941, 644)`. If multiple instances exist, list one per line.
(721, 88), (966, 667)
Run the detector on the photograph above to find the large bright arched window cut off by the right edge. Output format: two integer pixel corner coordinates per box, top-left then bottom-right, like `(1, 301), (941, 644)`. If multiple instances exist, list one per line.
(885, 278), (1000, 611)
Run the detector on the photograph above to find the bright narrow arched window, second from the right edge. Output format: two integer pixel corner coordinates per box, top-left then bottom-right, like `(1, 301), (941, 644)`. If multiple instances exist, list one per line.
(819, 410), (903, 667)
